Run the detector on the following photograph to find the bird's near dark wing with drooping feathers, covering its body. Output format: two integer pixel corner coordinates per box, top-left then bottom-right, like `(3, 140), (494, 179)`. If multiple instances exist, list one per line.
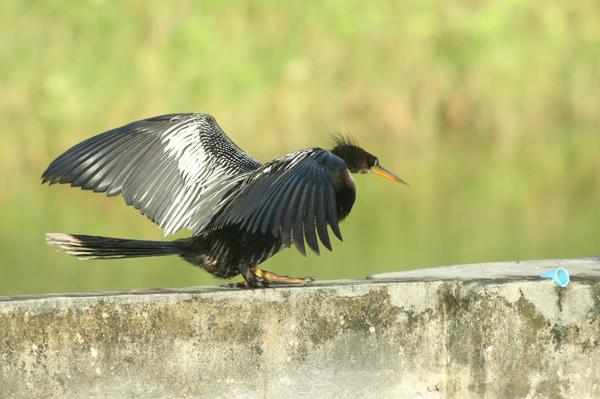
(211, 148), (346, 254)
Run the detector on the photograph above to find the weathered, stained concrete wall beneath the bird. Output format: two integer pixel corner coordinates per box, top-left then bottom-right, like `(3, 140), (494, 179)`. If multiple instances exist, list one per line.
(0, 259), (600, 399)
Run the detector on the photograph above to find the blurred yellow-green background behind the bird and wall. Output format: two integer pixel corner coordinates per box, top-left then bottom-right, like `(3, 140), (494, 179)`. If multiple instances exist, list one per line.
(0, 0), (600, 295)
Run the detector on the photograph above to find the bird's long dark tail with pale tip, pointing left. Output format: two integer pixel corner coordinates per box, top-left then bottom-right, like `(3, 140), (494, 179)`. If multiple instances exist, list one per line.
(46, 233), (181, 259)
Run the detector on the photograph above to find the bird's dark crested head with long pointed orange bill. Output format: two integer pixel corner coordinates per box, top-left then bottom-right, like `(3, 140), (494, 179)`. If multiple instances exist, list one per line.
(331, 137), (408, 185)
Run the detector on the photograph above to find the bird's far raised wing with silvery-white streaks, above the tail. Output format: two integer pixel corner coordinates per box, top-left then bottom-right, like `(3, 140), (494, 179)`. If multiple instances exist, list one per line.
(42, 114), (261, 235)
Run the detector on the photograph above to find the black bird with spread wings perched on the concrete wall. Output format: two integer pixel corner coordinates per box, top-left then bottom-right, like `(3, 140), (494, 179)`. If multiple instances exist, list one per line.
(42, 113), (404, 287)
